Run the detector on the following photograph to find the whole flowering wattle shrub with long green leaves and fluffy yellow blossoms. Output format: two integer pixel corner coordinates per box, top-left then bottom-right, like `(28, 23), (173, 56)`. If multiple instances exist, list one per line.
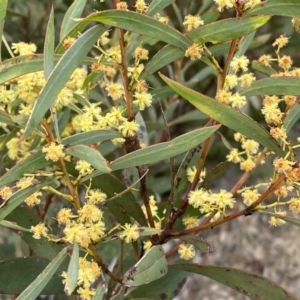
(0, 0), (300, 299)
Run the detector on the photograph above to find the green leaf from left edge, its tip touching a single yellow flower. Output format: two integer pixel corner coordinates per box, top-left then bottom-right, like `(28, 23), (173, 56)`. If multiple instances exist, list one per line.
(0, 150), (52, 186)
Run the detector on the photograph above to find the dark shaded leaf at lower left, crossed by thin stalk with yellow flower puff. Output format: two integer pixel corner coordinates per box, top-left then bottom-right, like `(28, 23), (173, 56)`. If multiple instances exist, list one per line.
(6, 206), (63, 260)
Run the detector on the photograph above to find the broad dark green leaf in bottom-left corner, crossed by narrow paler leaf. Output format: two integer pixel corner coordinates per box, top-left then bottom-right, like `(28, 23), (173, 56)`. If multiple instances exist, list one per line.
(0, 257), (64, 294)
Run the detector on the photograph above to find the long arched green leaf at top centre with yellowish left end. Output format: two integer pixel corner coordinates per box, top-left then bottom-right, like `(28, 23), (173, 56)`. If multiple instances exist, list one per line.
(85, 10), (191, 49)
